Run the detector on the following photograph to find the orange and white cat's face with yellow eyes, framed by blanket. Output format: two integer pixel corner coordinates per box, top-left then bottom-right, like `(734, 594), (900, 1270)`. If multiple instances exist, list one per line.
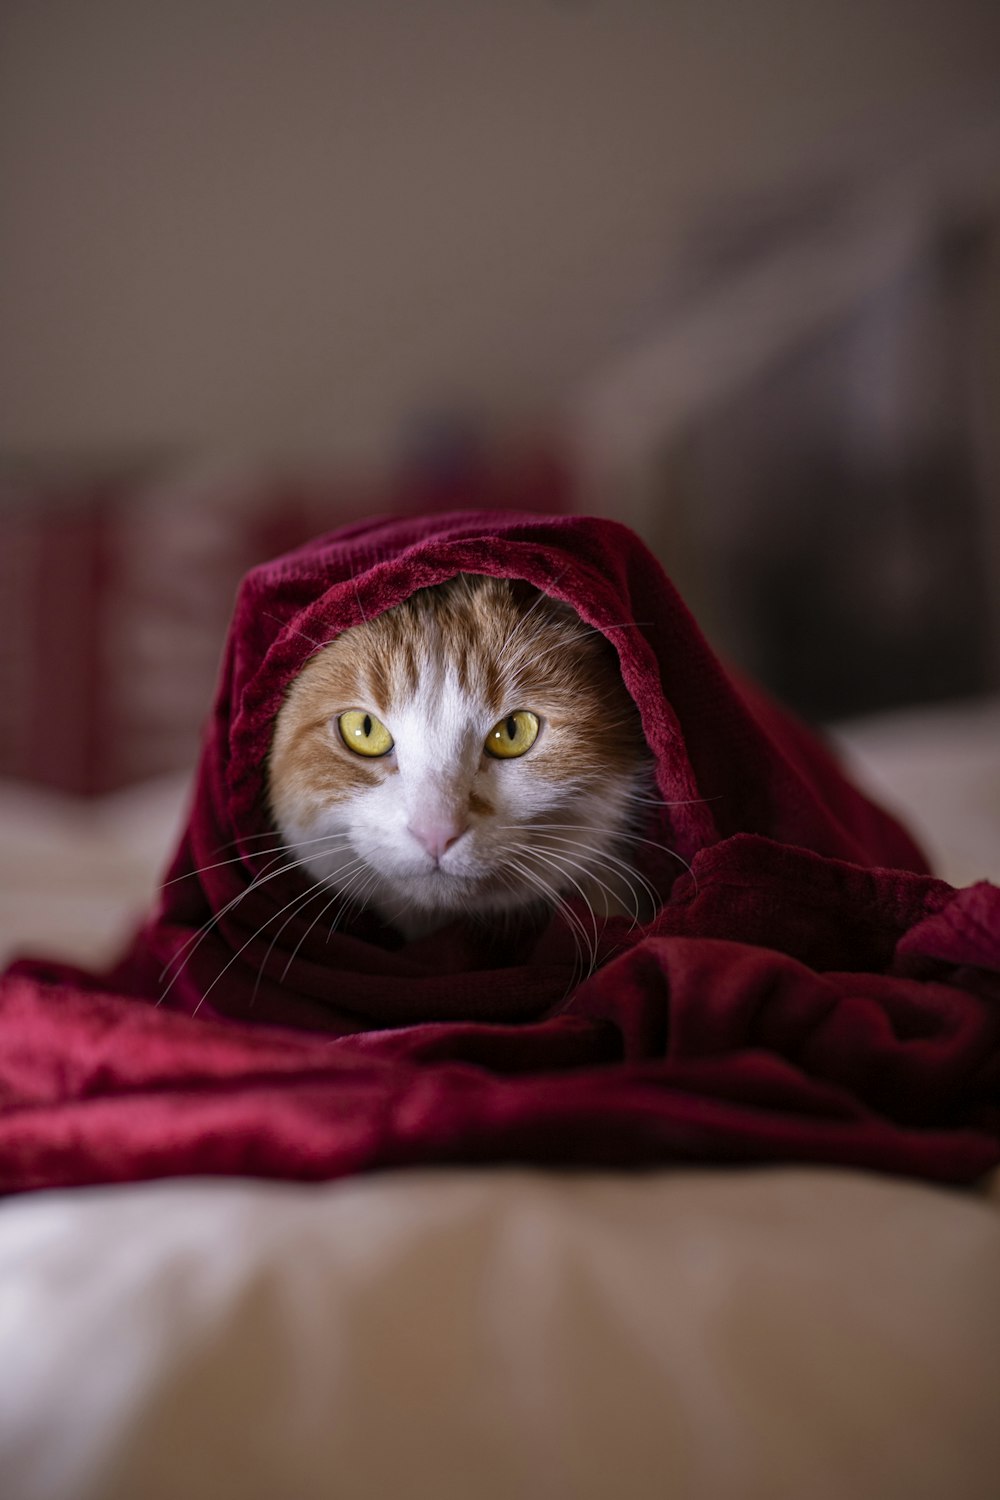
(268, 575), (649, 938)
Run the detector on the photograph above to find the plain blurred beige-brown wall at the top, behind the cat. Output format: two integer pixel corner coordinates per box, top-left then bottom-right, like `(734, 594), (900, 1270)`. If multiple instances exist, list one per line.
(0, 0), (1000, 461)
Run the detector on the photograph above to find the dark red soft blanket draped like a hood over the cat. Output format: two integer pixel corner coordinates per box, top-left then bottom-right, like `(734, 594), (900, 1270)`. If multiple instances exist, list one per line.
(0, 513), (1000, 1191)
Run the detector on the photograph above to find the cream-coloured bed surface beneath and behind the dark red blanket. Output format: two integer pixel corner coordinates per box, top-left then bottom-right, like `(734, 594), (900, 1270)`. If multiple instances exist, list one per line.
(0, 702), (1000, 1500)
